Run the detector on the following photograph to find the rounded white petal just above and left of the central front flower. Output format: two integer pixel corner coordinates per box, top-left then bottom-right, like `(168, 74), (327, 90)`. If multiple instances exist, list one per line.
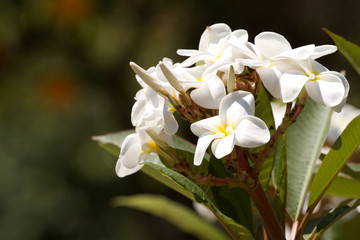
(190, 76), (226, 109)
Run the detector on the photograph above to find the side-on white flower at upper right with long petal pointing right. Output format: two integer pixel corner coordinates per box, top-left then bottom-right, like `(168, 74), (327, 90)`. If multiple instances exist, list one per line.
(231, 32), (337, 99)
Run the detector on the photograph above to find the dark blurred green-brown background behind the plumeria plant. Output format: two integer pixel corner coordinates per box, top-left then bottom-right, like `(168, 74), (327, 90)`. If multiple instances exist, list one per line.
(0, 0), (360, 240)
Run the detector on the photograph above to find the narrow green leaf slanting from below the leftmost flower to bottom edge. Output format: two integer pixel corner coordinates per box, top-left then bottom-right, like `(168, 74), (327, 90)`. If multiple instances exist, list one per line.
(145, 163), (253, 240)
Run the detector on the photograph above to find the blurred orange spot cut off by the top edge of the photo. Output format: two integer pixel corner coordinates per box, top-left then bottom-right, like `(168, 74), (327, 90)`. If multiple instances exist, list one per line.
(53, 0), (94, 25)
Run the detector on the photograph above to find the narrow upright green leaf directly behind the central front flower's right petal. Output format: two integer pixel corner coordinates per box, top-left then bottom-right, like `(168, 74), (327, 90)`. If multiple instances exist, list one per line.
(255, 85), (275, 191)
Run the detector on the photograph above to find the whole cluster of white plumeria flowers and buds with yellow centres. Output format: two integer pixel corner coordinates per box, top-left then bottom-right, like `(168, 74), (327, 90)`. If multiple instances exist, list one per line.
(116, 23), (349, 177)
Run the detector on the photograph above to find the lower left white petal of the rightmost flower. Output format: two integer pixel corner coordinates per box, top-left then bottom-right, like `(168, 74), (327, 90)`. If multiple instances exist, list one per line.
(279, 70), (309, 103)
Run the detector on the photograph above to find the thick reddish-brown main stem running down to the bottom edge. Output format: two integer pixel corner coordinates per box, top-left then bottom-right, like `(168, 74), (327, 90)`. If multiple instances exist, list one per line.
(248, 183), (285, 240)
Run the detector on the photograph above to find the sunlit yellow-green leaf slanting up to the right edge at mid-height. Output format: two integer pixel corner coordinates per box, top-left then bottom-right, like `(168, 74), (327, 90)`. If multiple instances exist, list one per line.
(309, 116), (360, 207)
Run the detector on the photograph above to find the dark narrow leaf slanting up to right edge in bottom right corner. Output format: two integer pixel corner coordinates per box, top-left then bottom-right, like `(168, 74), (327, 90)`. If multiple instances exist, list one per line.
(304, 200), (360, 239)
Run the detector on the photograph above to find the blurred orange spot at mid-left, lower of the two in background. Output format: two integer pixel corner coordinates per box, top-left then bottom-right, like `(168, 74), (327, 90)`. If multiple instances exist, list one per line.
(40, 71), (77, 110)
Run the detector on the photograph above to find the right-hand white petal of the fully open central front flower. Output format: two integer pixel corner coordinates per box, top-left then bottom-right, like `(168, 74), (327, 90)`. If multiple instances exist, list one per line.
(235, 116), (270, 148)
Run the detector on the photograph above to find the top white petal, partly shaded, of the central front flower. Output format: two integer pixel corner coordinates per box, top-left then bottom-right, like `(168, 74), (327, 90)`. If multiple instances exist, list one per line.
(219, 90), (255, 126)
